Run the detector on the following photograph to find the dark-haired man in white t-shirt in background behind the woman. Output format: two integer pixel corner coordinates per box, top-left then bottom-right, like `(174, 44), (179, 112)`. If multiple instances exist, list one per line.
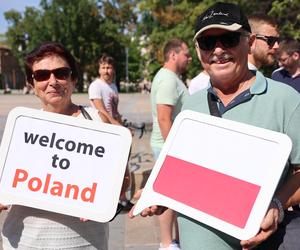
(88, 54), (122, 124)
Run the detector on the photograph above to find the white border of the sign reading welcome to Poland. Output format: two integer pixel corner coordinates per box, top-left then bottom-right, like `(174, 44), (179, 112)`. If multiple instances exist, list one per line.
(0, 107), (132, 222)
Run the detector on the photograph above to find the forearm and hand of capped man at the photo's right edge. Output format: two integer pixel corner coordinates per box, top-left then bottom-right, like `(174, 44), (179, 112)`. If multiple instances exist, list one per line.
(241, 165), (300, 250)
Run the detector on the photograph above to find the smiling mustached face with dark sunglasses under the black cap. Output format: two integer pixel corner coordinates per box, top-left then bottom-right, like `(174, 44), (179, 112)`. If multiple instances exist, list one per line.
(196, 29), (249, 83)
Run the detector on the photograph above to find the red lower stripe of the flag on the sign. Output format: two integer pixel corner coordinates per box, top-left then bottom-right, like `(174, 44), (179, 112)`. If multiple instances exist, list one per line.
(153, 156), (260, 228)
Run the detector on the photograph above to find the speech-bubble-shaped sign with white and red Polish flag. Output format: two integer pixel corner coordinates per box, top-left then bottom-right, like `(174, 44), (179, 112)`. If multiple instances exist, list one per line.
(134, 111), (292, 239)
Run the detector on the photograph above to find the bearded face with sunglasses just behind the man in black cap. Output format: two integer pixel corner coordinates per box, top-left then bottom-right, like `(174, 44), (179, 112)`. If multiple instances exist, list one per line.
(251, 24), (279, 66)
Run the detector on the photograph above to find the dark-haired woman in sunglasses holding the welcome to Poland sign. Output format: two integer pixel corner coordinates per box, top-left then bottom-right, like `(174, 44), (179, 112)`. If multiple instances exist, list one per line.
(0, 42), (128, 250)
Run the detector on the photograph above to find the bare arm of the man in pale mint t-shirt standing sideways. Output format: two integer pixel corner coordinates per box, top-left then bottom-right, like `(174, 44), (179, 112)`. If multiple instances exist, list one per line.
(156, 104), (174, 140)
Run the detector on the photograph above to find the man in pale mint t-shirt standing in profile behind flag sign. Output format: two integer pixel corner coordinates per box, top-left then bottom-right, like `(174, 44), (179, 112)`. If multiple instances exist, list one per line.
(151, 38), (191, 250)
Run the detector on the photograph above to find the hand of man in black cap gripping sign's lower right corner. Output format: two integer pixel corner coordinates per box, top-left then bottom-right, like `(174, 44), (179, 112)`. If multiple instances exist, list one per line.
(241, 203), (279, 250)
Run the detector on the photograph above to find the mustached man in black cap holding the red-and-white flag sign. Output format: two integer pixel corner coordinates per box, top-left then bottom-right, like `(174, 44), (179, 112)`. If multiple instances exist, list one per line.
(131, 3), (300, 250)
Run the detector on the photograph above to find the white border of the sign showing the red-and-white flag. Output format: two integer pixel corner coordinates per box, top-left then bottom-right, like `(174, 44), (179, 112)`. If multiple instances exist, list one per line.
(133, 110), (292, 240)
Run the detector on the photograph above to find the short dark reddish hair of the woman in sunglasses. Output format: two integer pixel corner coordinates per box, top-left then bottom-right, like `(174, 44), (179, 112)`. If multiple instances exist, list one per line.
(25, 42), (78, 85)
